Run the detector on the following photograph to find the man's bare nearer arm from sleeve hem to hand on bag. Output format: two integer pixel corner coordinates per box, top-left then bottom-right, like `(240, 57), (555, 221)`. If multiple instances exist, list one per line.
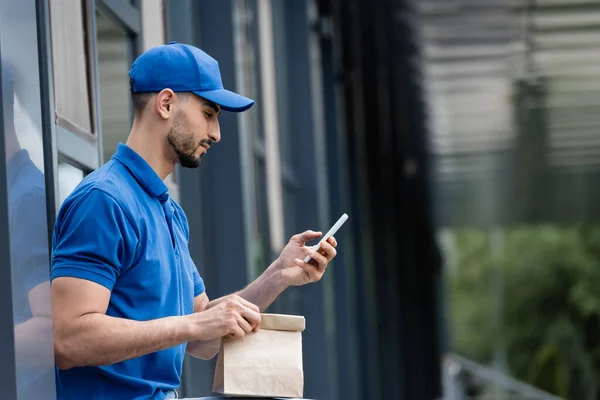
(52, 277), (260, 369)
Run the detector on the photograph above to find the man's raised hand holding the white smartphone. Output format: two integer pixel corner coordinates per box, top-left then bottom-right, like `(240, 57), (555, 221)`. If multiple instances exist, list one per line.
(277, 231), (337, 286)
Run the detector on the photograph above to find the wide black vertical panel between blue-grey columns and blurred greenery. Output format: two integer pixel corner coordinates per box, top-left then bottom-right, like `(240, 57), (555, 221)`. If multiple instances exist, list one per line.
(321, 0), (441, 399)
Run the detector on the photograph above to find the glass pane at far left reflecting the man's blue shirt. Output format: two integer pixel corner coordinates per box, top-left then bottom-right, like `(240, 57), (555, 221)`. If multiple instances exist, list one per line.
(0, 0), (56, 400)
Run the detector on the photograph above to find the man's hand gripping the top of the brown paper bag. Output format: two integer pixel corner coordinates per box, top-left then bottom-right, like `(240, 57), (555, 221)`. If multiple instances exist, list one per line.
(191, 295), (260, 340)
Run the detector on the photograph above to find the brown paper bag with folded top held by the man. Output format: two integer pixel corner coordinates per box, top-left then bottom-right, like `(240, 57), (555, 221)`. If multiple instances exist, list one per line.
(213, 314), (305, 397)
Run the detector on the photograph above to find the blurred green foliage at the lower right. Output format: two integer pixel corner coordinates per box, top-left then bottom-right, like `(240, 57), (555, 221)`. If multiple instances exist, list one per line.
(446, 225), (600, 400)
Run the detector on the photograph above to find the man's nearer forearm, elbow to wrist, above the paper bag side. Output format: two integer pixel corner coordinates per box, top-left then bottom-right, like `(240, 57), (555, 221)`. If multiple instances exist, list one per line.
(54, 313), (194, 369)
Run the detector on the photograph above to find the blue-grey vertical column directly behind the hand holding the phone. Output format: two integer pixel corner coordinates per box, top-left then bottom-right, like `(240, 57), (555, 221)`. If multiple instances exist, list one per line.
(270, 0), (338, 399)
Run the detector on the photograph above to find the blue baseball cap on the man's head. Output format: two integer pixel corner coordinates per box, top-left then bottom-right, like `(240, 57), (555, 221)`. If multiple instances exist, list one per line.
(129, 42), (254, 112)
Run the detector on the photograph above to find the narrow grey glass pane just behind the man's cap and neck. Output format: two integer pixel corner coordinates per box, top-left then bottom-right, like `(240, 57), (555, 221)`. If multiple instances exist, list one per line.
(96, 12), (132, 162)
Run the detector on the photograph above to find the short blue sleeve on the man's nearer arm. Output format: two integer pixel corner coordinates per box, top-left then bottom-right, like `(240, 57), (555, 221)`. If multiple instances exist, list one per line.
(52, 189), (138, 290)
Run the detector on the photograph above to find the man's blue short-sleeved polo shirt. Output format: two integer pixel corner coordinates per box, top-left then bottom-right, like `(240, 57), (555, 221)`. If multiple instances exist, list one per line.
(52, 144), (204, 400)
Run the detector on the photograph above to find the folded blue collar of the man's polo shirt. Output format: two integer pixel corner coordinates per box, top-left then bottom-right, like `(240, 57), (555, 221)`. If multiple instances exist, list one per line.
(113, 143), (169, 203)
